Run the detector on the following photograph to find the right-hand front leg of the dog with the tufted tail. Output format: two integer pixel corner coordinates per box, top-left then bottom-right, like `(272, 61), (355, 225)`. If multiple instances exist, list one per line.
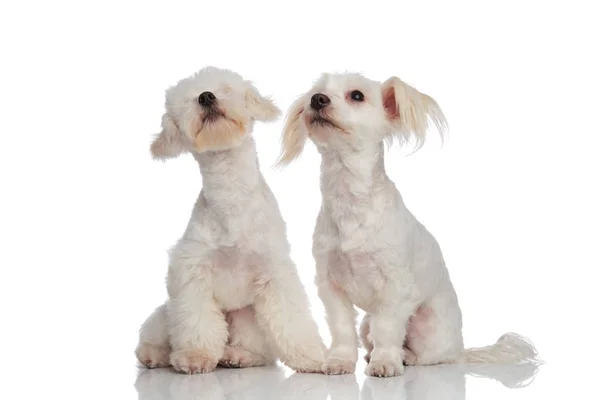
(365, 283), (417, 377)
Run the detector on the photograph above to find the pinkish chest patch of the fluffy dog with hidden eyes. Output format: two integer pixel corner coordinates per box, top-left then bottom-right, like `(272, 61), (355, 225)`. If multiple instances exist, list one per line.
(213, 250), (259, 311)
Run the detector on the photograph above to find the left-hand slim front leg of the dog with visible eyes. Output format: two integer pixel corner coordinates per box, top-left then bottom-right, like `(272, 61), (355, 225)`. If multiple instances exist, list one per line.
(317, 268), (358, 375)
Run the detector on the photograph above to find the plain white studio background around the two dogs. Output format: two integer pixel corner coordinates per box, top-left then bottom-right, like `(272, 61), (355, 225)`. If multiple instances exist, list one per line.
(0, 0), (600, 400)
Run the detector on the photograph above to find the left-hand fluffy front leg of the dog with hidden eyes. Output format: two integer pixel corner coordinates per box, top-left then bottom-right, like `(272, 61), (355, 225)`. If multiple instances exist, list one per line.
(167, 270), (227, 374)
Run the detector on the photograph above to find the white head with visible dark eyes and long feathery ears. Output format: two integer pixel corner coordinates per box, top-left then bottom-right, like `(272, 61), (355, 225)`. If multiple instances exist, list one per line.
(279, 74), (446, 165)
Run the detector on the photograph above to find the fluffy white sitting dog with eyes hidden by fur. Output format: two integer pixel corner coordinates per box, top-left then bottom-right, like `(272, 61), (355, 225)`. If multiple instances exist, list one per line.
(136, 67), (325, 373)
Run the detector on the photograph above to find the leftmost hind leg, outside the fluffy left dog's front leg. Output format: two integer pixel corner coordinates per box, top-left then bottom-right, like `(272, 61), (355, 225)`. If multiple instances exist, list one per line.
(135, 304), (171, 368)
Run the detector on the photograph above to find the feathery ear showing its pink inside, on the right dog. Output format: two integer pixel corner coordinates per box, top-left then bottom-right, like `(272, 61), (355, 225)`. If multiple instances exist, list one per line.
(381, 76), (447, 149)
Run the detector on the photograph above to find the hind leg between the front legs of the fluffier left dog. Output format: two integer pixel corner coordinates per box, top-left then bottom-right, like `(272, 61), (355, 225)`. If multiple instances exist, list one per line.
(219, 306), (277, 368)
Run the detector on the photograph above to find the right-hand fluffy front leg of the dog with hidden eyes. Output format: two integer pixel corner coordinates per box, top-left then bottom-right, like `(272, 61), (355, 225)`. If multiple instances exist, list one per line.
(254, 260), (325, 373)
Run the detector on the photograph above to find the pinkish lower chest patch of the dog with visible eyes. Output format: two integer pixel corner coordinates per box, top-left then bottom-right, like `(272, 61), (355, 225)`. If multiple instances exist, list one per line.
(328, 250), (385, 311)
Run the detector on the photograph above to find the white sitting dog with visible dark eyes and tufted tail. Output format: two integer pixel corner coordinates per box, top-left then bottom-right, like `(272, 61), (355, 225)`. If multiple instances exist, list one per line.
(280, 74), (536, 376)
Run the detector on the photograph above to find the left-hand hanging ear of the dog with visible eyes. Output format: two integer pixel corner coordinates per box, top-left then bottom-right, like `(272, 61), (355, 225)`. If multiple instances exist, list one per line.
(276, 95), (308, 167)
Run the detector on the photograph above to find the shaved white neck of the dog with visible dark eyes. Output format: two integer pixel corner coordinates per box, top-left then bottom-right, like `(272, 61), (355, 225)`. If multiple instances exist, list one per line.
(321, 143), (389, 207)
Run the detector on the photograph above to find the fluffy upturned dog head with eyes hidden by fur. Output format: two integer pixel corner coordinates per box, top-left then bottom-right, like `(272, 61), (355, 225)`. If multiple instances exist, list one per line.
(150, 67), (281, 159)
